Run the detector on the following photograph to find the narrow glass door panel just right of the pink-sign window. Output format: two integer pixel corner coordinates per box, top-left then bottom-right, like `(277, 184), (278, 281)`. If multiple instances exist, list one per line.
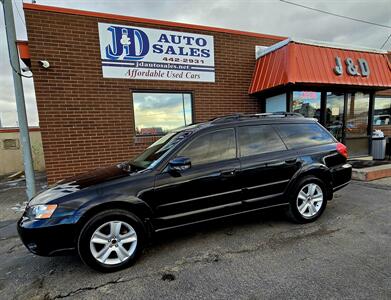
(325, 92), (345, 142)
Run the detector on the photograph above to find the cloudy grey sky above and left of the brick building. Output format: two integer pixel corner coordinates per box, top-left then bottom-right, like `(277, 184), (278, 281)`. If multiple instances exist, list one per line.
(0, 0), (391, 127)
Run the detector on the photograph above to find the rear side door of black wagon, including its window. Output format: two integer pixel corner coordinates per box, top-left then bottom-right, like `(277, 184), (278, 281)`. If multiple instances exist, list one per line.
(237, 125), (299, 208)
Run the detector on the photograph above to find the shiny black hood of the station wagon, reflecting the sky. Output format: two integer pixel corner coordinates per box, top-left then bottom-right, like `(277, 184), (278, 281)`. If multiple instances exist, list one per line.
(29, 163), (138, 206)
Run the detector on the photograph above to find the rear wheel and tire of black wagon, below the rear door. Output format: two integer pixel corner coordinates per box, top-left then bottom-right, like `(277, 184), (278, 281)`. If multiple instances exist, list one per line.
(287, 176), (327, 224)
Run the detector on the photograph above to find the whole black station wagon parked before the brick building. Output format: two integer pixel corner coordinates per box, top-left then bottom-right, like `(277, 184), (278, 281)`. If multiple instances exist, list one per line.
(18, 113), (352, 272)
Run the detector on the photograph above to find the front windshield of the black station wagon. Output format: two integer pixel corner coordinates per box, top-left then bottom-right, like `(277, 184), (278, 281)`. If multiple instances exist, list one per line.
(130, 130), (192, 169)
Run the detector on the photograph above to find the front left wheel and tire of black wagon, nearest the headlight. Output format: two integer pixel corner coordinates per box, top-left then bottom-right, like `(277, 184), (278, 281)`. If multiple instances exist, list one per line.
(77, 209), (146, 272)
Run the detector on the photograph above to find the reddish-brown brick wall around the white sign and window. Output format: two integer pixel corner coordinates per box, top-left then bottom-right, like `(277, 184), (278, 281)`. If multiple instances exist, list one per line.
(25, 8), (279, 183)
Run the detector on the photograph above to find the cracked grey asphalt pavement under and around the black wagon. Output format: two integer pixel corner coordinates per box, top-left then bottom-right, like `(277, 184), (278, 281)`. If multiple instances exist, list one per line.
(0, 182), (391, 299)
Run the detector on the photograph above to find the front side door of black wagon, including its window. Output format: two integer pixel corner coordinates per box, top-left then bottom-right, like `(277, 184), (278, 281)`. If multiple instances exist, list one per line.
(152, 128), (242, 228)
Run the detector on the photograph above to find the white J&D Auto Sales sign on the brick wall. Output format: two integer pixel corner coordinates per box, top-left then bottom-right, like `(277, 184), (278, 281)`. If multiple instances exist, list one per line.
(98, 23), (215, 82)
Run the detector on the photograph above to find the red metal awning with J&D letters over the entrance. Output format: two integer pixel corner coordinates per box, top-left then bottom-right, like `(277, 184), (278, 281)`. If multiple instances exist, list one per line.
(249, 40), (391, 94)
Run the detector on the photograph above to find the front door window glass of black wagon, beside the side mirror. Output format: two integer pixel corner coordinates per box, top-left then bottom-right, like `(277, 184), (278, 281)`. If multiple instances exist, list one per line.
(177, 128), (236, 165)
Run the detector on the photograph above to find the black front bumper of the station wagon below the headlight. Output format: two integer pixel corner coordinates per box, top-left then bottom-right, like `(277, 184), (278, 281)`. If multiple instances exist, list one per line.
(17, 216), (78, 256)
